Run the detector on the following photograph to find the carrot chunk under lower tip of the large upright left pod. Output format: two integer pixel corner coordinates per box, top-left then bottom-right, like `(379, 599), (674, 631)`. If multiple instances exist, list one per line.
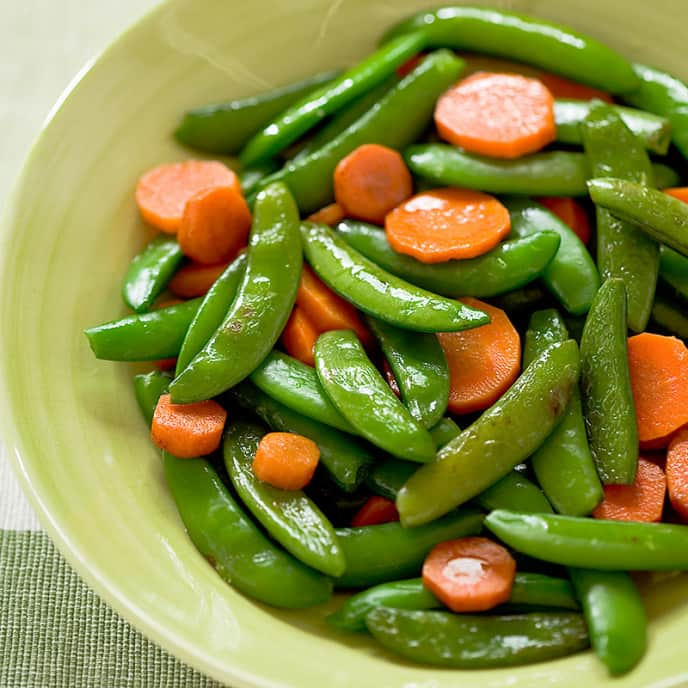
(151, 394), (227, 459)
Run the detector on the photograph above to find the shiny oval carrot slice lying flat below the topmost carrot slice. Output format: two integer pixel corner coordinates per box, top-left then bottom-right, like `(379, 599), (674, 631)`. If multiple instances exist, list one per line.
(385, 187), (511, 263)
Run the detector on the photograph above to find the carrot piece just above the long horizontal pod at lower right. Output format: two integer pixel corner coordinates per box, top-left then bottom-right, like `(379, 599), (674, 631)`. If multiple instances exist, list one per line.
(592, 456), (666, 523)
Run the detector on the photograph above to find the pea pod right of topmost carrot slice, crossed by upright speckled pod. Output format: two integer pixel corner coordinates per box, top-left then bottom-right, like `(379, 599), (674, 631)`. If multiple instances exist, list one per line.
(554, 98), (671, 155)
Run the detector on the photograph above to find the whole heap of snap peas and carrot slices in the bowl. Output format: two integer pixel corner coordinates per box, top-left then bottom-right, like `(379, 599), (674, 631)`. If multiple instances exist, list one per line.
(86, 6), (688, 674)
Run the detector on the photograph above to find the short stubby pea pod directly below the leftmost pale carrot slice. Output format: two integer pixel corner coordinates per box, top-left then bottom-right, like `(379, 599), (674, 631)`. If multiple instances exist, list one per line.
(122, 236), (184, 313)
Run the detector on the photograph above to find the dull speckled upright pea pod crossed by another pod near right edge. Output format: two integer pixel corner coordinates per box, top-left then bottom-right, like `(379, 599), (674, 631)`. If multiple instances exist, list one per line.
(581, 103), (659, 332)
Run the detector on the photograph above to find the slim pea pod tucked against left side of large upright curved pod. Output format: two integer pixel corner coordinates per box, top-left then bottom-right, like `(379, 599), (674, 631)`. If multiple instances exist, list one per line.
(175, 253), (247, 375)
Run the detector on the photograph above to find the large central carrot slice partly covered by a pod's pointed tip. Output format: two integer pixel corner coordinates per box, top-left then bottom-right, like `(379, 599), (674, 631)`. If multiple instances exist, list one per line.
(437, 298), (521, 413)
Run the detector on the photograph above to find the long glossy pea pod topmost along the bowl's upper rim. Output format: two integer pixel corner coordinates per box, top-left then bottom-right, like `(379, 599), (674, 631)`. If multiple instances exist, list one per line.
(383, 6), (638, 93)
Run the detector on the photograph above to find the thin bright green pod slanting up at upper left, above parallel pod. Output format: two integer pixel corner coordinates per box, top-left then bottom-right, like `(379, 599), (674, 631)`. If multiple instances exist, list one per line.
(241, 33), (425, 165)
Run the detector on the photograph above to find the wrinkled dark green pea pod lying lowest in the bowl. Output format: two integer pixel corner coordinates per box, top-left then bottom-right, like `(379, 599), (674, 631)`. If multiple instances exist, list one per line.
(366, 607), (589, 669)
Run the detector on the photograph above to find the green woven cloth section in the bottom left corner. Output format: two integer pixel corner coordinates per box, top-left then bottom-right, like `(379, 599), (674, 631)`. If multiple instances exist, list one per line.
(0, 531), (221, 688)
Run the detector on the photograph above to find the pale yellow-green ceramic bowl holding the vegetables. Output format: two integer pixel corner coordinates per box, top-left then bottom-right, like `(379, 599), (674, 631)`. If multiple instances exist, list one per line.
(0, 0), (688, 688)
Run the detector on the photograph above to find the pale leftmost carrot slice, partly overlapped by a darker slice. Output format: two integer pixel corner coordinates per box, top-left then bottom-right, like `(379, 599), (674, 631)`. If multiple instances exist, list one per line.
(136, 160), (241, 234)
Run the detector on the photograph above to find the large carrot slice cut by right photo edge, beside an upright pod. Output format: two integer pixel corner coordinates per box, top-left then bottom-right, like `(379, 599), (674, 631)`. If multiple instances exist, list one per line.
(628, 332), (688, 449)
